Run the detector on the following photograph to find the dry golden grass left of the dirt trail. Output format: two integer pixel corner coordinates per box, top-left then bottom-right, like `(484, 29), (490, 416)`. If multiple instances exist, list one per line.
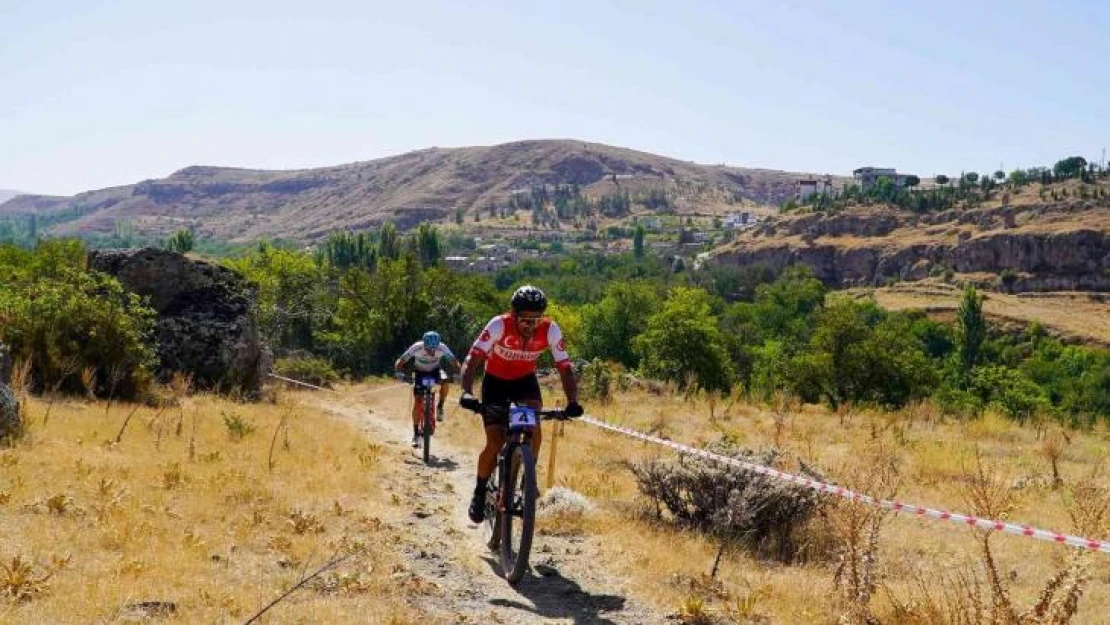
(0, 394), (417, 623)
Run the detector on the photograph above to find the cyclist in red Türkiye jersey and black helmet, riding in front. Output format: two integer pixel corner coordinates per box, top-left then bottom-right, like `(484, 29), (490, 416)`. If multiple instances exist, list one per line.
(458, 285), (583, 523)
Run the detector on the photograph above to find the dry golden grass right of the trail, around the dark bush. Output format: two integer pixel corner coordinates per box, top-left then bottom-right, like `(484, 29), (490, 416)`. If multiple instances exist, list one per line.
(526, 381), (1110, 623)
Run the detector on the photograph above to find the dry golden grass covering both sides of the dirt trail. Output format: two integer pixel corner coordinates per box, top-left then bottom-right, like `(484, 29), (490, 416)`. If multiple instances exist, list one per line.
(0, 375), (1110, 624)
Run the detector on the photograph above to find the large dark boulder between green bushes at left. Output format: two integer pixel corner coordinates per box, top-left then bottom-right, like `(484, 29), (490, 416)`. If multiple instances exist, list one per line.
(89, 248), (272, 395)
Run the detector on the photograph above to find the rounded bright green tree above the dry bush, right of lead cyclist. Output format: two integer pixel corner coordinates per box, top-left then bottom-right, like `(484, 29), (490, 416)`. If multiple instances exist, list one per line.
(633, 288), (733, 390)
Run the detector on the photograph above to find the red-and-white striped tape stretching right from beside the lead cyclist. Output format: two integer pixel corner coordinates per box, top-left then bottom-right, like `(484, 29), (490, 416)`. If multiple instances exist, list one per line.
(578, 416), (1110, 553)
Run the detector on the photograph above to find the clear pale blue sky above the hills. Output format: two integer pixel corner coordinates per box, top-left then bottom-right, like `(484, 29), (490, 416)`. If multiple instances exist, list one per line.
(0, 0), (1110, 194)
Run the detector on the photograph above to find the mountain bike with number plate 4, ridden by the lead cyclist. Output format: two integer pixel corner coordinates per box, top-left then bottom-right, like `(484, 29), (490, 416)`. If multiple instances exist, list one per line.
(468, 404), (568, 584)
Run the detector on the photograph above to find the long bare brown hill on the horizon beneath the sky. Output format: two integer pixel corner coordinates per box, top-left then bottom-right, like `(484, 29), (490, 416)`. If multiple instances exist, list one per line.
(0, 140), (825, 241)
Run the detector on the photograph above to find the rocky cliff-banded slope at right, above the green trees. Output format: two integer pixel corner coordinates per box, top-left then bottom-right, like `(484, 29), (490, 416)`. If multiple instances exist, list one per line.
(715, 199), (1110, 292)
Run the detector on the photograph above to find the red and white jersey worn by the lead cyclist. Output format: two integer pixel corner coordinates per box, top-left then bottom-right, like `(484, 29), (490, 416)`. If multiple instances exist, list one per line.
(471, 313), (571, 380)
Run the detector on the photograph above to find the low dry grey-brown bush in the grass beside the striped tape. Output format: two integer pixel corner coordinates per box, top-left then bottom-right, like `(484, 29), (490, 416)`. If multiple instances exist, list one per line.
(629, 443), (824, 561)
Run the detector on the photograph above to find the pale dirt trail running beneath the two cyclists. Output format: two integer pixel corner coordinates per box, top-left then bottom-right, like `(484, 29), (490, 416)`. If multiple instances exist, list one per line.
(314, 389), (667, 624)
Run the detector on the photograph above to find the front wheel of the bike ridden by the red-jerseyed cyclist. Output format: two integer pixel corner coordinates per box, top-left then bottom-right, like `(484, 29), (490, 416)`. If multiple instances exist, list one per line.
(501, 445), (536, 584)
